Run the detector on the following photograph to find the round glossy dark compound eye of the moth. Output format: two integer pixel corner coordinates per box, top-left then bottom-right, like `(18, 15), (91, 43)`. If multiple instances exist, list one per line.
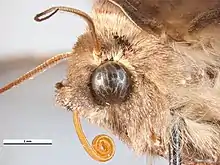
(91, 61), (132, 104)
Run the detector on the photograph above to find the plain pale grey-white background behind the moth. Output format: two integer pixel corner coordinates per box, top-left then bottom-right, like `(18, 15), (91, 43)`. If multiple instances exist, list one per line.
(0, 0), (166, 165)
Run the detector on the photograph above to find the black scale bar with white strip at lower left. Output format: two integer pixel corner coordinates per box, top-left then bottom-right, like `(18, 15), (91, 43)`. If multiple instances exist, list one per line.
(3, 139), (52, 146)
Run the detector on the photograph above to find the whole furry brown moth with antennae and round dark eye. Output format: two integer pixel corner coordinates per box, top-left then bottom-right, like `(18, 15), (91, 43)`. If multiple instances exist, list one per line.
(0, 0), (220, 165)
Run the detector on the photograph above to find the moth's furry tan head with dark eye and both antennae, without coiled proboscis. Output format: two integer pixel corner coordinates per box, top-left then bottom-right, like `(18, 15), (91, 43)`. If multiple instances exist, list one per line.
(0, 6), (168, 155)
